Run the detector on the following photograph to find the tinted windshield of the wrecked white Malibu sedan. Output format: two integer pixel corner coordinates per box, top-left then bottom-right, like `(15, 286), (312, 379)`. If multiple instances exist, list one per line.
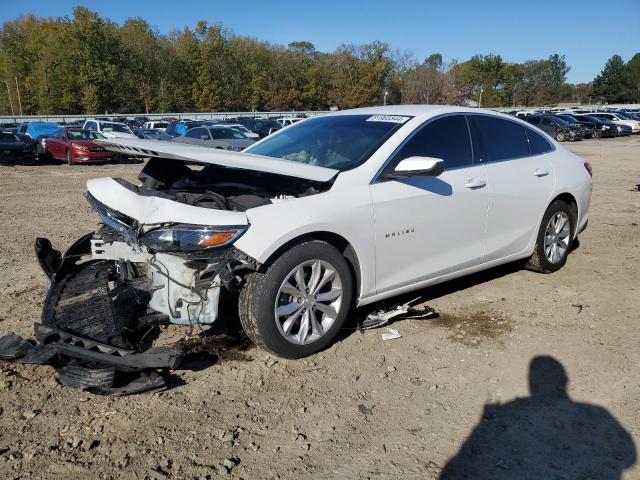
(246, 115), (411, 170)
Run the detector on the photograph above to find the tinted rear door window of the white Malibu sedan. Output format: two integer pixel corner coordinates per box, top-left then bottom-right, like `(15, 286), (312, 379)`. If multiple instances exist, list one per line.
(469, 115), (530, 162)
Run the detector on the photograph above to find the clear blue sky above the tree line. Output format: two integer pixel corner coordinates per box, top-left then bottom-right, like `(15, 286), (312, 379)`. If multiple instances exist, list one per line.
(0, 0), (640, 83)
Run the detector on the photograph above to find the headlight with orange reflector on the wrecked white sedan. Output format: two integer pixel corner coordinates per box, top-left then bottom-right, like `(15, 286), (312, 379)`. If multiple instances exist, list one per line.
(140, 224), (245, 252)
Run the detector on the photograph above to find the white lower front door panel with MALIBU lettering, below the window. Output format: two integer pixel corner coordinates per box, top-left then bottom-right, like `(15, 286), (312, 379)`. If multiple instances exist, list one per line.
(370, 165), (489, 293)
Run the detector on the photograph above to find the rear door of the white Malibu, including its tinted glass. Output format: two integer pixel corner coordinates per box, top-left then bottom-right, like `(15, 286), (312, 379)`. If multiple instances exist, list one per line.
(468, 114), (555, 262)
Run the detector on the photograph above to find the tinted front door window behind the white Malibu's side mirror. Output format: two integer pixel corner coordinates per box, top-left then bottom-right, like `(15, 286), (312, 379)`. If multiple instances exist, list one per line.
(391, 115), (473, 170)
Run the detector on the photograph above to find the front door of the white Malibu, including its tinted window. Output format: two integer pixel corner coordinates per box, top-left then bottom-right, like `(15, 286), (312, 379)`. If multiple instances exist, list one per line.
(370, 114), (489, 293)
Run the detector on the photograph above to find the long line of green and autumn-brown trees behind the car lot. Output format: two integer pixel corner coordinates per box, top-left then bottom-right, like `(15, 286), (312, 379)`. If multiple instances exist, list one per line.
(0, 7), (640, 115)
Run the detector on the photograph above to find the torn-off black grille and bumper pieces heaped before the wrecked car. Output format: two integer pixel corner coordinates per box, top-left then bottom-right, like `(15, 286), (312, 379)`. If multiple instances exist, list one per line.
(0, 234), (184, 395)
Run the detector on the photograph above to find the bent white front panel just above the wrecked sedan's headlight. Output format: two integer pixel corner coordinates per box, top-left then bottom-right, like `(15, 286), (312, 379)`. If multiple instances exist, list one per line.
(87, 178), (249, 226)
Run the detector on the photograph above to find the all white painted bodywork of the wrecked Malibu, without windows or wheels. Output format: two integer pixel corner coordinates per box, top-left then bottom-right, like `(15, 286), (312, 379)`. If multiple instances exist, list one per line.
(88, 105), (591, 312)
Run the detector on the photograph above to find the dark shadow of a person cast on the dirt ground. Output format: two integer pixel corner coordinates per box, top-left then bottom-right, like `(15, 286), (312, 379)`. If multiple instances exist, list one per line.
(440, 356), (636, 480)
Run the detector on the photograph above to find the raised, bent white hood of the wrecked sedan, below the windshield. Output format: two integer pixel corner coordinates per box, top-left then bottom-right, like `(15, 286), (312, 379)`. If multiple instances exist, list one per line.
(96, 138), (339, 182)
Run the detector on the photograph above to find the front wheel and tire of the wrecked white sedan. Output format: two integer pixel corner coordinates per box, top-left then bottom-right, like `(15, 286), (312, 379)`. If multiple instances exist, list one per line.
(238, 241), (353, 358)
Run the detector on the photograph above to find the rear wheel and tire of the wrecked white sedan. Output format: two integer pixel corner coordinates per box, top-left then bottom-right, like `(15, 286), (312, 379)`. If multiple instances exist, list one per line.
(527, 200), (576, 273)
